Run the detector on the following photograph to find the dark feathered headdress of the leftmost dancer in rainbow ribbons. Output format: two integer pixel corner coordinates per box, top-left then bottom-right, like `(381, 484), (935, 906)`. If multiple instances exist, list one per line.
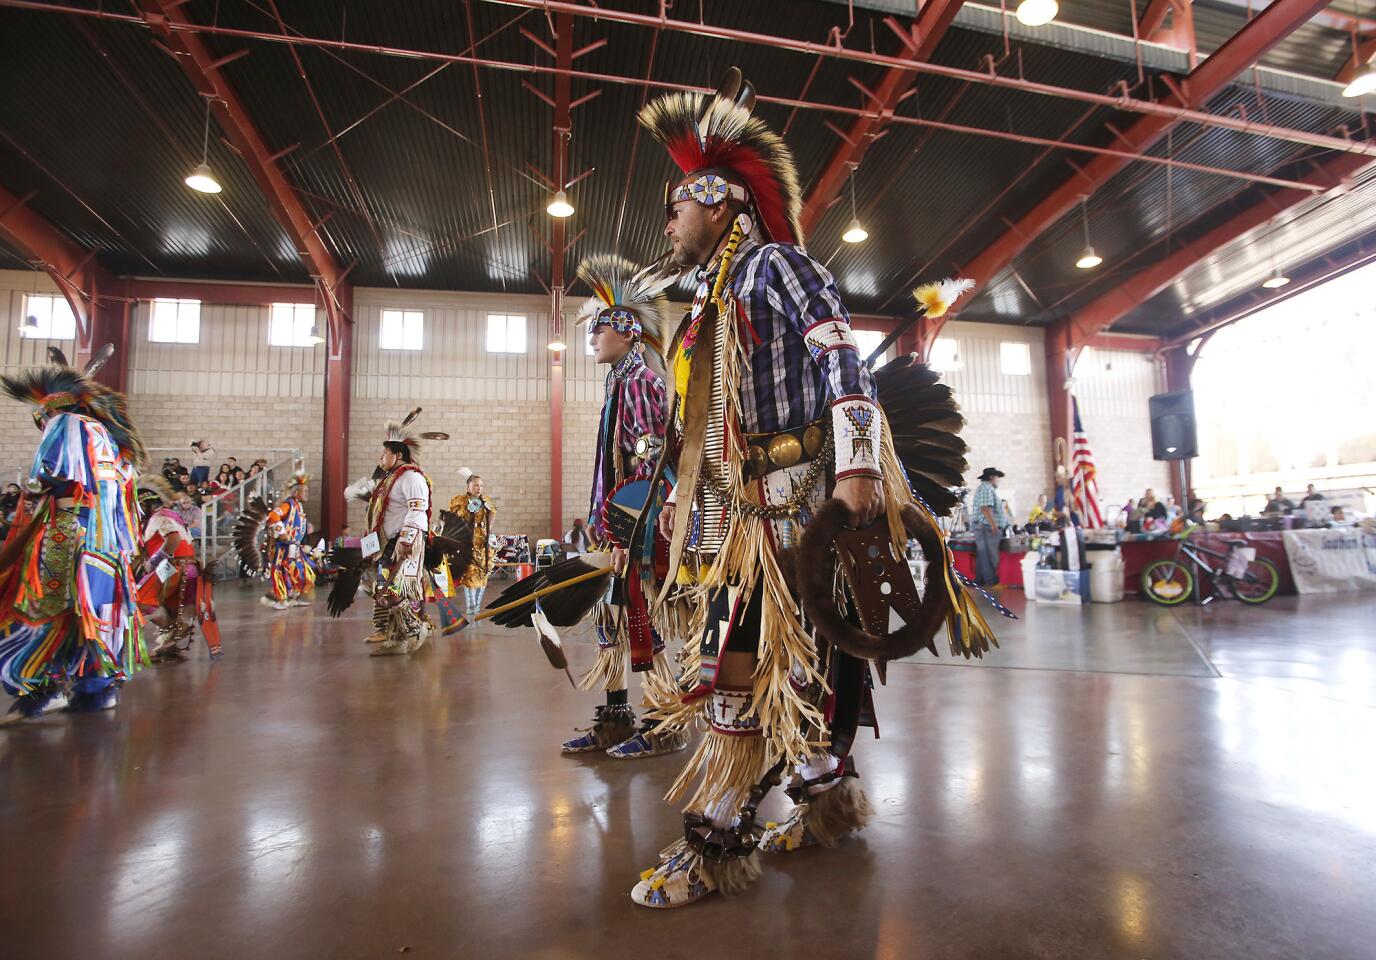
(0, 344), (147, 465)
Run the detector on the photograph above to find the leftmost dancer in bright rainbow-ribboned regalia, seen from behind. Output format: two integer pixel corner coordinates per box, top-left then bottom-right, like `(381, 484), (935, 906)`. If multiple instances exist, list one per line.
(0, 345), (147, 722)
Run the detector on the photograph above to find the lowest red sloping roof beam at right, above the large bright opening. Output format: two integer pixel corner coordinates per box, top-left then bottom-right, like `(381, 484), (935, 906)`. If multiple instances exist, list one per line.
(1057, 154), (1370, 353)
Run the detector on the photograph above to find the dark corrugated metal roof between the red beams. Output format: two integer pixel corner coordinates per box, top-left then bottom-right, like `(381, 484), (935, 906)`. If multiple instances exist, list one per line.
(0, 0), (1369, 329)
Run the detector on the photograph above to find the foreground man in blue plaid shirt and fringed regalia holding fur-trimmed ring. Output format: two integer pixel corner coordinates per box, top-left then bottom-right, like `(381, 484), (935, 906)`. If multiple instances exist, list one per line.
(632, 69), (988, 908)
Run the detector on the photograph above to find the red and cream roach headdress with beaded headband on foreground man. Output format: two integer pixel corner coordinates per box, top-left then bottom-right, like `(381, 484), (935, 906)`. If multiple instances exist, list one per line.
(640, 67), (802, 243)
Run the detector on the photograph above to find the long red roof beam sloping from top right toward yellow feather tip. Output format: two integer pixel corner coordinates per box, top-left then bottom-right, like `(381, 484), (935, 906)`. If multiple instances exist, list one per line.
(932, 0), (1326, 337)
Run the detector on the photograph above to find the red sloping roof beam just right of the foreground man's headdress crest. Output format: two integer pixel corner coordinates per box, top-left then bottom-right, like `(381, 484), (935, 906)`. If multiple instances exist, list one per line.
(801, 0), (965, 235)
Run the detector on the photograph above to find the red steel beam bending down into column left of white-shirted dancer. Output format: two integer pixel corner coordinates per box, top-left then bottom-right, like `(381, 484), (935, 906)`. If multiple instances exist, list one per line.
(139, 0), (354, 536)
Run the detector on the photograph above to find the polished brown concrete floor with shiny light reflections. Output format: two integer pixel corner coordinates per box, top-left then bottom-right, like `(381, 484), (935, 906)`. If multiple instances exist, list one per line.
(0, 586), (1376, 960)
